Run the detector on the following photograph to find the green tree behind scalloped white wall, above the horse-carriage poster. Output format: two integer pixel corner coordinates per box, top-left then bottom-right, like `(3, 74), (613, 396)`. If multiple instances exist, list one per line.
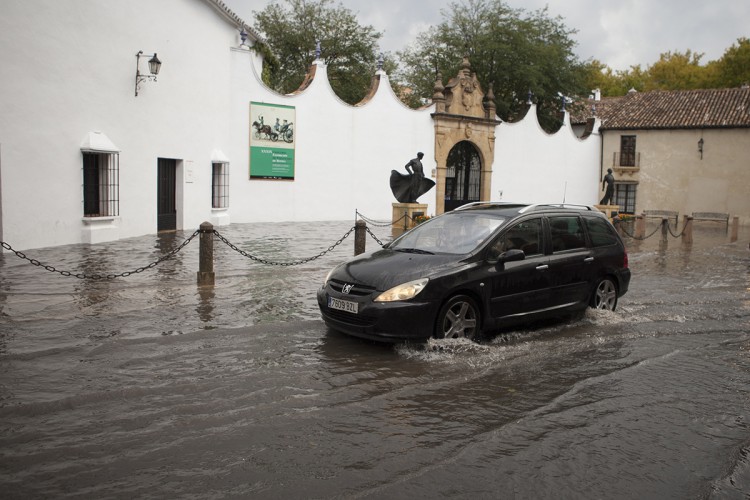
(254, 0), (382, 104)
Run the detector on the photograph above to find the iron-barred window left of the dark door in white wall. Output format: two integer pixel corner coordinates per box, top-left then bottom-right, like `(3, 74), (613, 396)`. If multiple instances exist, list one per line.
(83, 152), (120, 217)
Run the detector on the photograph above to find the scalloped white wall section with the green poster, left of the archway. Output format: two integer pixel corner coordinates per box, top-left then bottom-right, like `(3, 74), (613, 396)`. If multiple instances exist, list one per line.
(230, 51), (435, 222)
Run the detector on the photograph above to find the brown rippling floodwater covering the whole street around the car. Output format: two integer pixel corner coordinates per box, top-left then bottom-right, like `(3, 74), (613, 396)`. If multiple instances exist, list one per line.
(0, 222), (750, 500)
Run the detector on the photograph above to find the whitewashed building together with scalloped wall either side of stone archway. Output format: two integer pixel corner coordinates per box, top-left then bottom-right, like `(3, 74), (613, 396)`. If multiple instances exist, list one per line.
(0, 0), (601, 250)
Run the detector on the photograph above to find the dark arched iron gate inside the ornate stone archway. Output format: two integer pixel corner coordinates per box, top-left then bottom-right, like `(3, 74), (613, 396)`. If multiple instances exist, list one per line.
(445, 141), (482, 212)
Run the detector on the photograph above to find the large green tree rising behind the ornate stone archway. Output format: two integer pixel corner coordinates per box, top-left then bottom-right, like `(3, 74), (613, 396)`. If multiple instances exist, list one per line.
(399, 0), (590, 130)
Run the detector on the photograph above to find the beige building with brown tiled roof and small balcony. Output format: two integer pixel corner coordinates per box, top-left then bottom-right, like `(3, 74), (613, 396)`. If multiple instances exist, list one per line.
(578, 87), (750, 224)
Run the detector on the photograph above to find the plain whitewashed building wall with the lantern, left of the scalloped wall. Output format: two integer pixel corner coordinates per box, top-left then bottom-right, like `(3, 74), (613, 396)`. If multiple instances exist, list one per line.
(0, 0), (256, 249)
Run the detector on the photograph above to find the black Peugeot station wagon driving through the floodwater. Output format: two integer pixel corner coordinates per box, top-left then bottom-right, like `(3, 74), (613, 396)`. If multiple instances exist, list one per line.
(317, 202), (630, 342)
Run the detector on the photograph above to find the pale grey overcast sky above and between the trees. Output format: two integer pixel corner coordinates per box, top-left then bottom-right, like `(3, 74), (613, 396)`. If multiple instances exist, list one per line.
(224, 0), (750, 70)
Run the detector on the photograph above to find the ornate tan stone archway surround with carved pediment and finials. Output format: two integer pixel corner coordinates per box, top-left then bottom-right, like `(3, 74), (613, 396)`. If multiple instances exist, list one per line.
(432, 57), (500, 215)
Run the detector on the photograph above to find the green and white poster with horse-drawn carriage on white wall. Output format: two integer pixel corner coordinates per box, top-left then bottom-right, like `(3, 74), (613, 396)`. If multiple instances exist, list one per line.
(250, 101), (295, 180)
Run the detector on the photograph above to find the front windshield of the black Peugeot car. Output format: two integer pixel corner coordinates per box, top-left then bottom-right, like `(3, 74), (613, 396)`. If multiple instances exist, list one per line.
(389, 212), (506, 254)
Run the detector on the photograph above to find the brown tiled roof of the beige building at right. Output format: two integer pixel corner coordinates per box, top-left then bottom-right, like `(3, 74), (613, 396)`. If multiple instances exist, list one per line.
(589, 88), (750, 130)
